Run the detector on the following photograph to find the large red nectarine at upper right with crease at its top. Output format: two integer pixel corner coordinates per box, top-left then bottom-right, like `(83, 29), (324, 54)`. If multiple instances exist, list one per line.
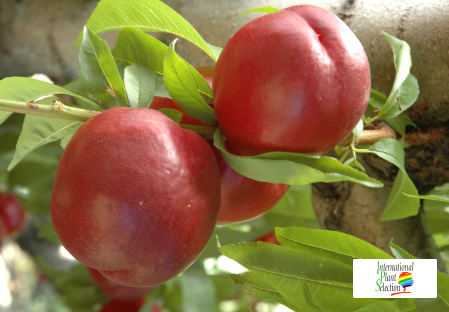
(213, 5), (371, 155)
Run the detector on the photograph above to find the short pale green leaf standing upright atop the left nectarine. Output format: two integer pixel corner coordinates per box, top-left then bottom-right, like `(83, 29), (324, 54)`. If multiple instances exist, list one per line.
(125, 63), (158, 108)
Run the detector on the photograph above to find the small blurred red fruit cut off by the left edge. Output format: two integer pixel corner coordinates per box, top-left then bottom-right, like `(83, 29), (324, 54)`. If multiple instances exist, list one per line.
(0, 193), (25, 234)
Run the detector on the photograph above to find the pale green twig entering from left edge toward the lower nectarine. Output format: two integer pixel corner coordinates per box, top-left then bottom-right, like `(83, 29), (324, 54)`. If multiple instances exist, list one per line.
(0, 99), (100, 121)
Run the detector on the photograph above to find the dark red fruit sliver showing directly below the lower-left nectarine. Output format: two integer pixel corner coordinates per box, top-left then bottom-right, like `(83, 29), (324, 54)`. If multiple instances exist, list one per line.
(88, 268), (153, 301)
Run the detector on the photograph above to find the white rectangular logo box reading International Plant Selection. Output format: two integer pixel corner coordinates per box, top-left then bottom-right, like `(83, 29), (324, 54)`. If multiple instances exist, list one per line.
(353, 259), (437, 299)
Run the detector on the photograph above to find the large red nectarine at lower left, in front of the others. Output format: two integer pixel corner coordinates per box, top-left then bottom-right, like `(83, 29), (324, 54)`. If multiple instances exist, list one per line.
(51, 107), (220, 287)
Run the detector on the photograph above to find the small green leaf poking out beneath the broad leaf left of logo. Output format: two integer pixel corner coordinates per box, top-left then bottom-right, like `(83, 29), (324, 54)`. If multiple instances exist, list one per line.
(230, 272), (296, 311)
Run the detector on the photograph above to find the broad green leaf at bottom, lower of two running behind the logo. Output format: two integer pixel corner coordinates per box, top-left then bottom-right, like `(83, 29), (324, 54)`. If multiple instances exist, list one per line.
(219, 242), (381, 312)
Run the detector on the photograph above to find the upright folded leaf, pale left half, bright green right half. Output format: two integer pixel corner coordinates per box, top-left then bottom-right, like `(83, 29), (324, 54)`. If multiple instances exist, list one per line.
(78, 26), (128, 108)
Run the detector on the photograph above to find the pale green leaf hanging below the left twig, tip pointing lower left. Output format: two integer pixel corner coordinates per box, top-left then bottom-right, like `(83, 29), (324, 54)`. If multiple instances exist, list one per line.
(8, 115), (82, 171)
